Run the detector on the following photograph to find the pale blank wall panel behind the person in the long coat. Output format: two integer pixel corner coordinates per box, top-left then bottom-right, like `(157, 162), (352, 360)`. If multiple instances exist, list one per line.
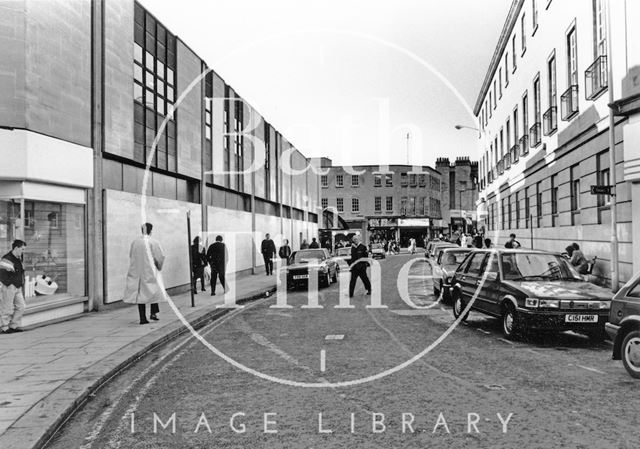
(104, 190), (202, 303)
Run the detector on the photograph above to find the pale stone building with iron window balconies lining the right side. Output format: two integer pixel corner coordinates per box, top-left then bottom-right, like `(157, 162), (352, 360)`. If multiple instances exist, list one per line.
(474, 0), (640, 288)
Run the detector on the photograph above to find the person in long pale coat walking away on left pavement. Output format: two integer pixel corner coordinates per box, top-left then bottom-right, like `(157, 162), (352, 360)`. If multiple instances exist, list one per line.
(123, 223), (165, 324)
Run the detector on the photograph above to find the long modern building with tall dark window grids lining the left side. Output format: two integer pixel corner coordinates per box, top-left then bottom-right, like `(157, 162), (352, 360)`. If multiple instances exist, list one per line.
(0, 0), (320, 325)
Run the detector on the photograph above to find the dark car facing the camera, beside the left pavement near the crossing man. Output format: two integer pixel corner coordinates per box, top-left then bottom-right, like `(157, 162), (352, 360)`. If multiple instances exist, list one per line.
(286, 248), (340, 288)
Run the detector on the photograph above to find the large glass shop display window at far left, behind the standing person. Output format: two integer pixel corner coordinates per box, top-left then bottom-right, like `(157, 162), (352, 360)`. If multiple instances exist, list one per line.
(0, 199), (86, 302)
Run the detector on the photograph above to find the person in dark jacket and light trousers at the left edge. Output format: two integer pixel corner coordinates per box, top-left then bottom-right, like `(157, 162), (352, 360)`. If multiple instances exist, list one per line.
(0, 239), (27, 334)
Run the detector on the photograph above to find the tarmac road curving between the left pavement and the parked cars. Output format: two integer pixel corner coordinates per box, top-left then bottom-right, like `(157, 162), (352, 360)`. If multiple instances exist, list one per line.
(49, 255), (640, 449)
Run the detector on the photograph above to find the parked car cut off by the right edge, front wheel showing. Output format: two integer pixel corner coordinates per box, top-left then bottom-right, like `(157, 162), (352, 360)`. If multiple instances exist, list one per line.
(606, 274), (640, 379)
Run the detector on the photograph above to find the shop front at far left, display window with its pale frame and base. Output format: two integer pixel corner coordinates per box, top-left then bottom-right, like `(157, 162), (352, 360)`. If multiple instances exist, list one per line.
(0, 181), (88, 326)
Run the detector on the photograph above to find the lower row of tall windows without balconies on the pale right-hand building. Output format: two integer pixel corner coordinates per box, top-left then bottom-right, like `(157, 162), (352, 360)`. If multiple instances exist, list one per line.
(487, 151), (611, 230)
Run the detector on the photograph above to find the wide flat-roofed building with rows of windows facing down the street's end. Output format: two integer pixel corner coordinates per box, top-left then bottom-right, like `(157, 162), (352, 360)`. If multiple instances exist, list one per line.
(320, 159), (442, 246)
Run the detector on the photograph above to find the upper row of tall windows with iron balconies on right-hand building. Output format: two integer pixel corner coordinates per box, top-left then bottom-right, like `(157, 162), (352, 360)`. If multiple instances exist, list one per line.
(479, 0), (608, 188)
